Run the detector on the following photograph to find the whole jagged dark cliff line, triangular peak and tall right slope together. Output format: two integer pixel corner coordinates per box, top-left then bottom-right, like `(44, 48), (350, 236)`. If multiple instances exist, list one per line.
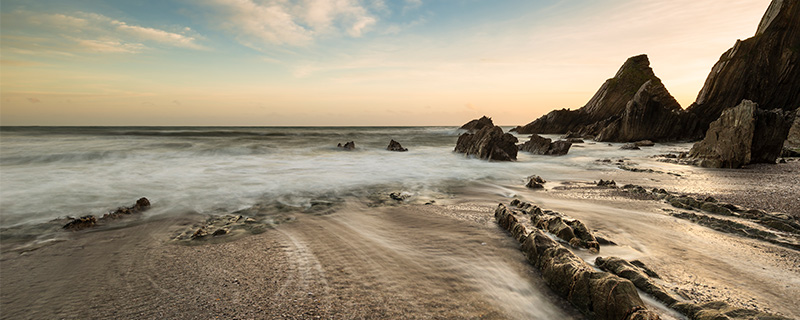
(515, 0), (800, 142)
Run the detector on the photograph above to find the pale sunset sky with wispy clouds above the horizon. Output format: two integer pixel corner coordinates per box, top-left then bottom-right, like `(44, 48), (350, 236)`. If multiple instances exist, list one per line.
(0, 0), (770, 126)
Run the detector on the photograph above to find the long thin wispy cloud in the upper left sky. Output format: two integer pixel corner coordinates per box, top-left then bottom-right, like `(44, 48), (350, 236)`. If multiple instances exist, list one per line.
(1, 10), (204, 53)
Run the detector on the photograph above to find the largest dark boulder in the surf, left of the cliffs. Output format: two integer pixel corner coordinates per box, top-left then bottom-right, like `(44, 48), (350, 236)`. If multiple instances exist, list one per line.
(454, 126), (518, 161)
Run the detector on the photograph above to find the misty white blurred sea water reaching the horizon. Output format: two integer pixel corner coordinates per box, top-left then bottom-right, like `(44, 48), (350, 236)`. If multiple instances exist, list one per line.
(0, 127), (688, 227)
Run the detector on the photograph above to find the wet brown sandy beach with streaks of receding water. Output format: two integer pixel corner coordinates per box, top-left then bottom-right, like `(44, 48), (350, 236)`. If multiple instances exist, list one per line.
(0, 162), (800, 319)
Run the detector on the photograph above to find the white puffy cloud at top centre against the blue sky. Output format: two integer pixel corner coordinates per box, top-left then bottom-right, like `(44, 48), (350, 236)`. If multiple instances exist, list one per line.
(206, 0), (385, 49)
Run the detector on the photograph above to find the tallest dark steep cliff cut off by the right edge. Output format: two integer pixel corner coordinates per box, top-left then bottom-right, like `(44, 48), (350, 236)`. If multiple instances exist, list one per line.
(686, 0), (800, 138)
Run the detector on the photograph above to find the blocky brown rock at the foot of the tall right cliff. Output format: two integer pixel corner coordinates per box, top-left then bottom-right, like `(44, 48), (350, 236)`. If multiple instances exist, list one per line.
(689, 100), (791, 168)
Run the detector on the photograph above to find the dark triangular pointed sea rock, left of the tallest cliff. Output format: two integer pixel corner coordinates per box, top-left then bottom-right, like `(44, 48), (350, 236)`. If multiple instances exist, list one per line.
(515, 55), (685, 142)
